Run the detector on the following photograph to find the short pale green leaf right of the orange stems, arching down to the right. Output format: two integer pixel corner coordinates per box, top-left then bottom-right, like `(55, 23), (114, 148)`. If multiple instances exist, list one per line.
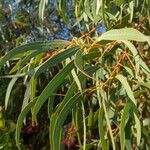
(116, 74), (137, 105)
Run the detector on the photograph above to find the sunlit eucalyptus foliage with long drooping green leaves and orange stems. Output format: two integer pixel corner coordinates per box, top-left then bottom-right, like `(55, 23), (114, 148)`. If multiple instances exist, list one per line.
(0, 0), (150, 150)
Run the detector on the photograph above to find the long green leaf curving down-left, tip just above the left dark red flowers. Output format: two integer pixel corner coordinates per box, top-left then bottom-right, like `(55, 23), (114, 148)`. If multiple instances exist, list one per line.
(33, 62), (74, 120)
